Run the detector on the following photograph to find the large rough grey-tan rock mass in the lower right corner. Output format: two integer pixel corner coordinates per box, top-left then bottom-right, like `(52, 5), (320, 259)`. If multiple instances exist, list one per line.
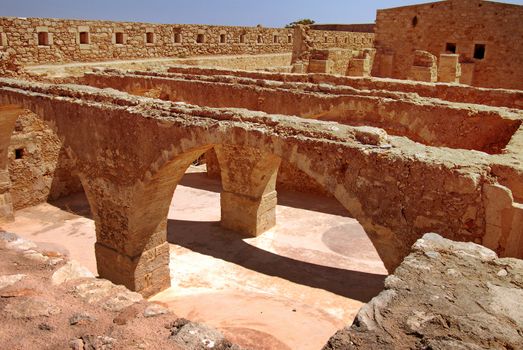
(324, 233), (523, 350)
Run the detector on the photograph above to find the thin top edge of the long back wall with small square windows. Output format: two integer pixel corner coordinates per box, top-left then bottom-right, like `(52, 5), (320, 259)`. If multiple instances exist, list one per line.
(0, 16), (292, 32)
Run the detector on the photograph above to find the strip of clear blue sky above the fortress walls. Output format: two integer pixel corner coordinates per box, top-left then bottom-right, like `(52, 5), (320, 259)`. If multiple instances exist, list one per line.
(0, 0), (523, 27)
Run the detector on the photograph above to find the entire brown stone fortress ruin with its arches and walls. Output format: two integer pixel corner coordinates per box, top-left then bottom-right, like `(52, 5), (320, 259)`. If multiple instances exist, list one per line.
(0, 0), (523, 349)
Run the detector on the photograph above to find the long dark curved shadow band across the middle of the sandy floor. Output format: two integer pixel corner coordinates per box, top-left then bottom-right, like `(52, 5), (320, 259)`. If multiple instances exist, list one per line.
(167, 220), (386, 302)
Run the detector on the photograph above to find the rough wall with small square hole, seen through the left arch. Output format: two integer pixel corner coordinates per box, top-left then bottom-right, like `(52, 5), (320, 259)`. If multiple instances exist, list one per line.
(8, 111), (82, 210)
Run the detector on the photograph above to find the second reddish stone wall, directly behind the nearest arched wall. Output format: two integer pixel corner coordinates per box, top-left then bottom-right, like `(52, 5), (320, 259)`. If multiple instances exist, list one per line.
(84, 71), (522, 153)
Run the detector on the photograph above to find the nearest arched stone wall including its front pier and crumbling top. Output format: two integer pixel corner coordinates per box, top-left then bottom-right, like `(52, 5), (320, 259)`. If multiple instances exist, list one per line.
(0, 79), (523, 295)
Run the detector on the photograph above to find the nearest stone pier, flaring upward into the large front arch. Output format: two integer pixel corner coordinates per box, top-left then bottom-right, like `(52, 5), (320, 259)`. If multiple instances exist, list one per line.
(85, 147), (210, 297)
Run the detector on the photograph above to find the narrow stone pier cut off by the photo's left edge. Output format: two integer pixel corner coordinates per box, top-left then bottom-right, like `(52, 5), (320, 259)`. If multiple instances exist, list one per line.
(0, 105), (24, 223)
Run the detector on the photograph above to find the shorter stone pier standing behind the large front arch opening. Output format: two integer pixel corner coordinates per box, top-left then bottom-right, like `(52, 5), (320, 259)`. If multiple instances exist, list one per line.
(215, 145), (281, 236)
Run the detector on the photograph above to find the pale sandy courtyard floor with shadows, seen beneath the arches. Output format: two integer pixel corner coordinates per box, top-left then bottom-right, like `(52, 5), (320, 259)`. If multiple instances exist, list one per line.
(4, 167), (386, 350)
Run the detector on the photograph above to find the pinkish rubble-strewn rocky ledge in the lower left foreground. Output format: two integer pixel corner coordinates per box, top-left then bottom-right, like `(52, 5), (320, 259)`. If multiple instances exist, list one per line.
(0, 231), (243, 350)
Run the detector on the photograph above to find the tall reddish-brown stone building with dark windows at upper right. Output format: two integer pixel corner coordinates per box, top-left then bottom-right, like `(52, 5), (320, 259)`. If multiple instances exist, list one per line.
(373, 0), (523, 89)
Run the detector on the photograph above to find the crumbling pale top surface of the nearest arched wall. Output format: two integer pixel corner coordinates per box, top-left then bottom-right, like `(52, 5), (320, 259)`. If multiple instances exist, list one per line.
(0, 78), (500, 174)
